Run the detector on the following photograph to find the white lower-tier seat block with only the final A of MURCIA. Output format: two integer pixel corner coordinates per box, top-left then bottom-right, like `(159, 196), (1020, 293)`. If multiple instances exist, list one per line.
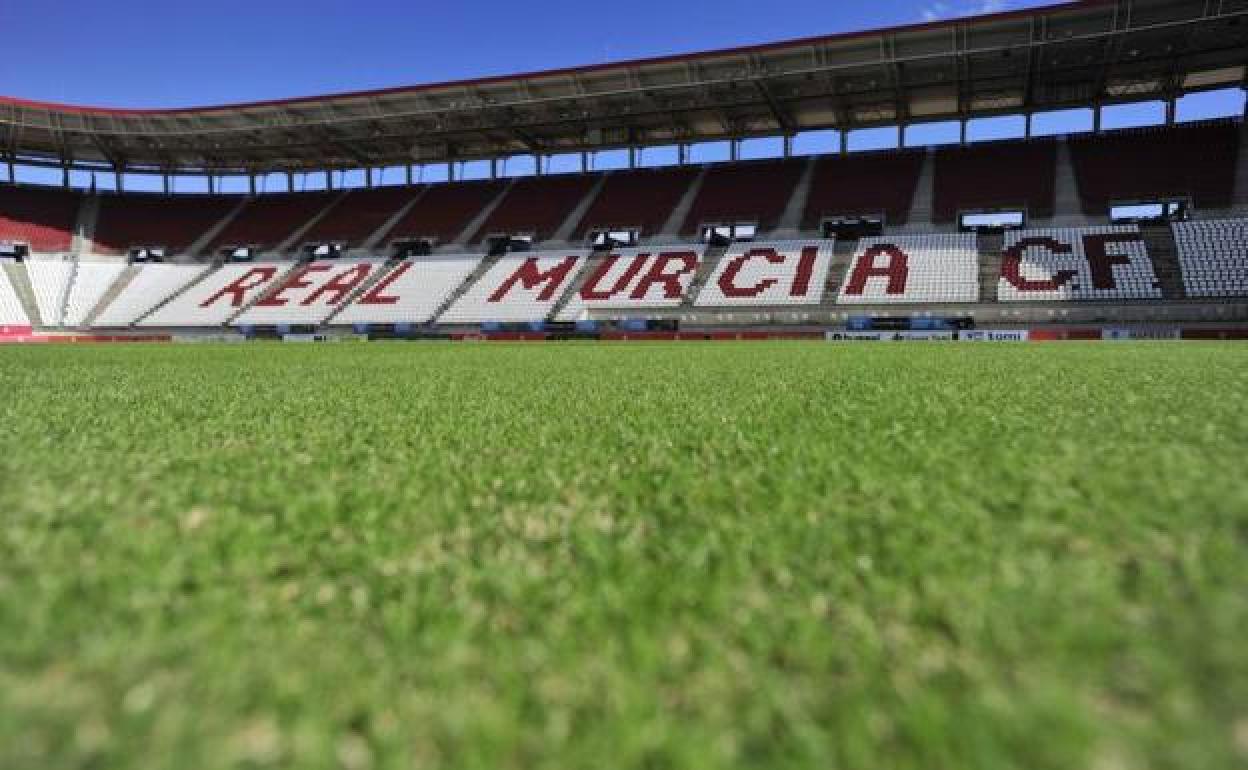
(836, 233), (980, 305)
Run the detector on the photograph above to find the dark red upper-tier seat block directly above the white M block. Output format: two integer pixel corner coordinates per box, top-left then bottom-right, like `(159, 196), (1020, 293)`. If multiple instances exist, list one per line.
(474, 173), (600, 241)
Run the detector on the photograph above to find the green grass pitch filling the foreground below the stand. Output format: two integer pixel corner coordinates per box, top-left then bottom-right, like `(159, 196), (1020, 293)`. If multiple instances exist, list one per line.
(0, 343), (1248, 770)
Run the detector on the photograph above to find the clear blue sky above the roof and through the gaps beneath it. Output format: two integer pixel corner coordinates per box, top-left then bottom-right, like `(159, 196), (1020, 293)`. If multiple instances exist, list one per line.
(0, 0), (1243, 189)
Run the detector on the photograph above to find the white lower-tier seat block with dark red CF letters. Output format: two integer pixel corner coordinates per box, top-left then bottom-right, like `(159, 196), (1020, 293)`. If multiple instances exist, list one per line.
(997, 225), (1162, 302)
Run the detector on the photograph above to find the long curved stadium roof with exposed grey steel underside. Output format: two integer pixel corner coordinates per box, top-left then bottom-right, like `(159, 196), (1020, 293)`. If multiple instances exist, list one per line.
(0, 0), (1248, 173)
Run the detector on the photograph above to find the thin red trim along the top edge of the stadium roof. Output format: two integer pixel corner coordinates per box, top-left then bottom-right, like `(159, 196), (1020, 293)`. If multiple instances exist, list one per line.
(0, 0), (1116, 116)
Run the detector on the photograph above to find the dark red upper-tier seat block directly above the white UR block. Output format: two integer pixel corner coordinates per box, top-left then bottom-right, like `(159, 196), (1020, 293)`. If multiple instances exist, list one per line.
(575, 166), (698, 241)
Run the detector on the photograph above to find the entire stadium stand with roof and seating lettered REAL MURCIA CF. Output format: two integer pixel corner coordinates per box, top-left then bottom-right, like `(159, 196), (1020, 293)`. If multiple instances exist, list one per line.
(0, 0), (1248, 338)
